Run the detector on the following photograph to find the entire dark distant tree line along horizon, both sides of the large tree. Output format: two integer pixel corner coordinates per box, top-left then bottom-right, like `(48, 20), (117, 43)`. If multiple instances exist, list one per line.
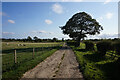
(0, 36), (120, 42)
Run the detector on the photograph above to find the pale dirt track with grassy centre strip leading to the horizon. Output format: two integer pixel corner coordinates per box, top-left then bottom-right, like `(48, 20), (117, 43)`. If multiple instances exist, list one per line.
(22, 45), (83, 80)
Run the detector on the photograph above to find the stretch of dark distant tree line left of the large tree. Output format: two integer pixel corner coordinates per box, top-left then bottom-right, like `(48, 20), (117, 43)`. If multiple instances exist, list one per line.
(2, 36), (64, 42)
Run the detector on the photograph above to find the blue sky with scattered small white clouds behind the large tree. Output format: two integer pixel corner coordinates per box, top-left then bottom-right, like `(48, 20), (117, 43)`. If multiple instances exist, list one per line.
(0, 2), (118, 39)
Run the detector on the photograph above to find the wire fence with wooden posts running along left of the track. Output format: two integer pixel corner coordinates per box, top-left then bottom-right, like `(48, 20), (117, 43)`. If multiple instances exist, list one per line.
(2, 43), (61, 72)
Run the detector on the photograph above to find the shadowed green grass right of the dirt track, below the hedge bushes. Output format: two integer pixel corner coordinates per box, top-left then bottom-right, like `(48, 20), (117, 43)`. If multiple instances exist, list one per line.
(71, 43), (120, 80)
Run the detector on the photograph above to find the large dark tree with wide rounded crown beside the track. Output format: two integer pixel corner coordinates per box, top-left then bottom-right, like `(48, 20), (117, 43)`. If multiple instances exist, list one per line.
(60, 12), (103, 46)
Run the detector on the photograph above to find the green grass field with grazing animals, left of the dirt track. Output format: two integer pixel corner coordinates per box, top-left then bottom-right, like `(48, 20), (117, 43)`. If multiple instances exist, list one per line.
(2, 42), (63, 80)
